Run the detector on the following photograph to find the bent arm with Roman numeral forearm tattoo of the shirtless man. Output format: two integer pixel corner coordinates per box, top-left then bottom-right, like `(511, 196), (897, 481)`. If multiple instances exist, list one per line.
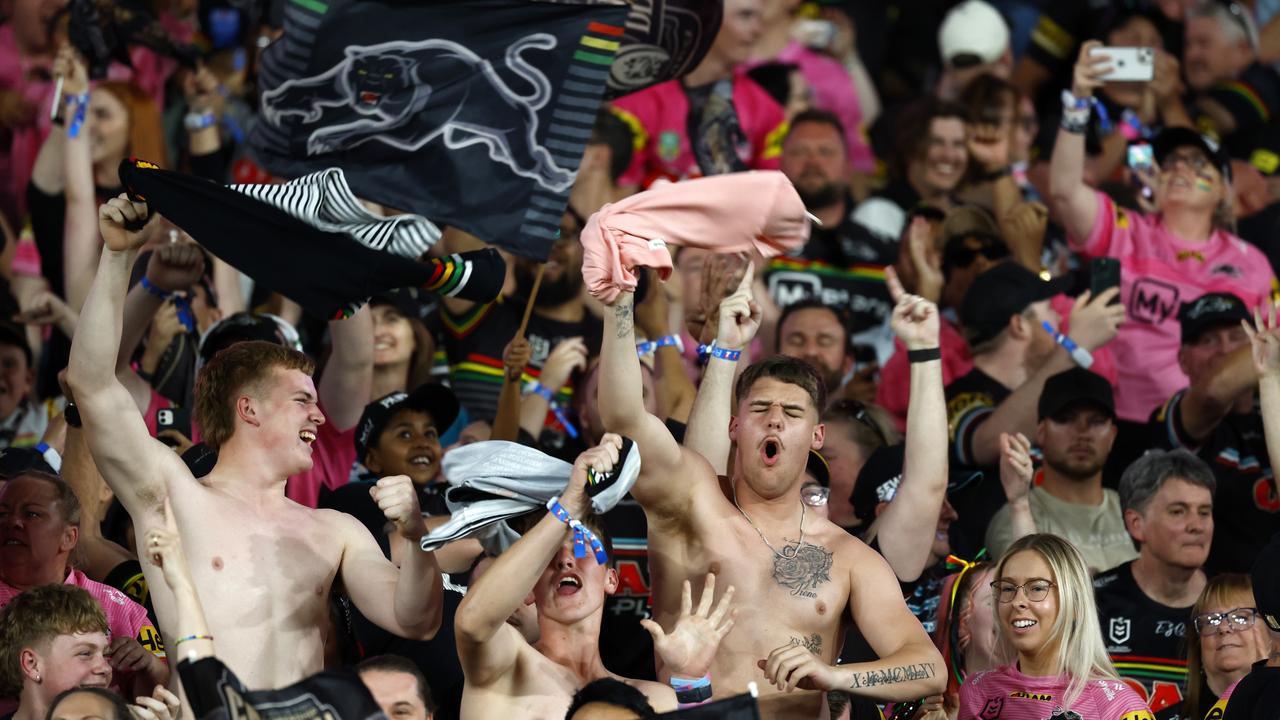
(756, 546), (947, 702)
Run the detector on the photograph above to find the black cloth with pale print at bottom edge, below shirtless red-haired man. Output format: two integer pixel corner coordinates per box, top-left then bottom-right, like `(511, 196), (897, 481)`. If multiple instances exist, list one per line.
(178, 657), (387, 720)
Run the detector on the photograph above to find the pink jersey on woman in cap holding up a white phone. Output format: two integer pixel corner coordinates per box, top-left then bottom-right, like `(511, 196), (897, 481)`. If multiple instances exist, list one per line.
(1071, 192), (1275, 423)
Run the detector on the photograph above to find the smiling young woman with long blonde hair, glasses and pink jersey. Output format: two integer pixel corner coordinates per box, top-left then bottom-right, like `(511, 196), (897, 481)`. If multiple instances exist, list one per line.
(959, 534), (1155, 720)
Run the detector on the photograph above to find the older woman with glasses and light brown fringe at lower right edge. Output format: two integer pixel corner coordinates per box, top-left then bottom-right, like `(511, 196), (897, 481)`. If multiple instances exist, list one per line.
(1180, 573), (1270, 720)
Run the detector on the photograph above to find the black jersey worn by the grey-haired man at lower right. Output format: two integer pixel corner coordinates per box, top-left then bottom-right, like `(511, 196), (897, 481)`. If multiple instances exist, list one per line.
(1093, 561), (1192, 712)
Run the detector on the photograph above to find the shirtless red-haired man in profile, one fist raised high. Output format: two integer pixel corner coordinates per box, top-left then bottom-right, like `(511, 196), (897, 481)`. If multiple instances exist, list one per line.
(68, 195), (443, 688)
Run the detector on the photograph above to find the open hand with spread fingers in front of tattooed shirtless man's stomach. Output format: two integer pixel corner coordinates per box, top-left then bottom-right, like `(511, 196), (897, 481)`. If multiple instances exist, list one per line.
(640, 573), (737, 678)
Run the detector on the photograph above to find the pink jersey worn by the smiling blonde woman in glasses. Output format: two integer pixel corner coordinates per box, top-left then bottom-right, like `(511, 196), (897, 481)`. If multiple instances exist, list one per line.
(959, 665), (1155, 720)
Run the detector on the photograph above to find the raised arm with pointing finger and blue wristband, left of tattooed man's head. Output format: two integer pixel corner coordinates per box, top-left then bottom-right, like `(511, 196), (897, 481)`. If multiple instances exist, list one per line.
(685, 263), (760, 475)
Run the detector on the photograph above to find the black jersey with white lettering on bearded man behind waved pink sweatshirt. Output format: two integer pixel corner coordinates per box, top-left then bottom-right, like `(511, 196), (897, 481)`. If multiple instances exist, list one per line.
(764, 199), (897, 342)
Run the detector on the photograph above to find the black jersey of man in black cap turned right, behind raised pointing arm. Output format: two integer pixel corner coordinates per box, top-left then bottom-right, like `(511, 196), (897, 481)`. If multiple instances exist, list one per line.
(946, 368), (1012, 557)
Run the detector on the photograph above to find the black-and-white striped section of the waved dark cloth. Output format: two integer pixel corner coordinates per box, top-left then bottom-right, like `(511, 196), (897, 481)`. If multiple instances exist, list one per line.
(229, 168), (440, 260)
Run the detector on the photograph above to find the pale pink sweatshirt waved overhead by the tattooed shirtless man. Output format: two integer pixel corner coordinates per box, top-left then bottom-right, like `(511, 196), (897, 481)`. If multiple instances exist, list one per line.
(581, 170), (809, 302)
